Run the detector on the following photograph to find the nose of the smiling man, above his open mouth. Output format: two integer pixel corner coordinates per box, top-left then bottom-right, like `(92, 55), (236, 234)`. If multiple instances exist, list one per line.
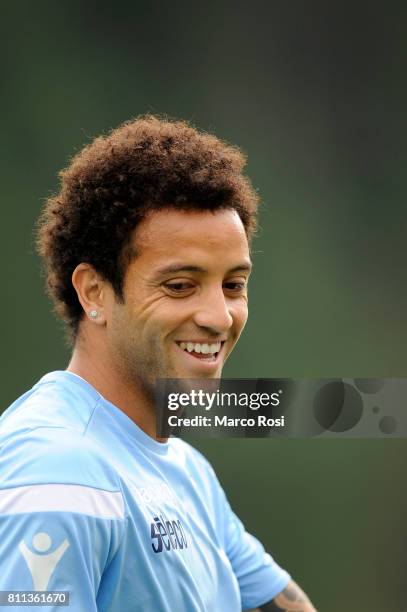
(194, 288), (233, 334)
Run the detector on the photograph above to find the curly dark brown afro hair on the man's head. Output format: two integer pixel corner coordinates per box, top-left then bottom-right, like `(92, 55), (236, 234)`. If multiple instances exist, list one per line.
(37, 115), (258, 339)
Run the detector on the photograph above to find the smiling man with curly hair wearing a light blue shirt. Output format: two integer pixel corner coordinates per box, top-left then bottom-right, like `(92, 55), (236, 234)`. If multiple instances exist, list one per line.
(0, 116), (314, 612)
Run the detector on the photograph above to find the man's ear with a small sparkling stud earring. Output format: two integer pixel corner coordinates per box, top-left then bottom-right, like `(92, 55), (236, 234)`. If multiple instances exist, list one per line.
(72, 263), (106, 325)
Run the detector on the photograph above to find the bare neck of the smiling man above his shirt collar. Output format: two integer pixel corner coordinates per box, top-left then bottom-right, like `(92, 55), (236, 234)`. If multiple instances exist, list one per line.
(67, 342), (166, 442)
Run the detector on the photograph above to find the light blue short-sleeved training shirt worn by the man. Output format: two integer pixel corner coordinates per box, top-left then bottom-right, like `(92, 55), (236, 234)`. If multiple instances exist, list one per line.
(0, 371), (290, 612)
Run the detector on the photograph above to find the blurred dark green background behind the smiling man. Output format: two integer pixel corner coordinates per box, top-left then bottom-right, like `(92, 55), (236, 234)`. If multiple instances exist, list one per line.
(0, 0), (407, 612)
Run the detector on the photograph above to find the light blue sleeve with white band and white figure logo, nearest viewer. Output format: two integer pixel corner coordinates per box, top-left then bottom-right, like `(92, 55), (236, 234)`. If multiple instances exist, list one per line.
(0, 429), (125, 612)
